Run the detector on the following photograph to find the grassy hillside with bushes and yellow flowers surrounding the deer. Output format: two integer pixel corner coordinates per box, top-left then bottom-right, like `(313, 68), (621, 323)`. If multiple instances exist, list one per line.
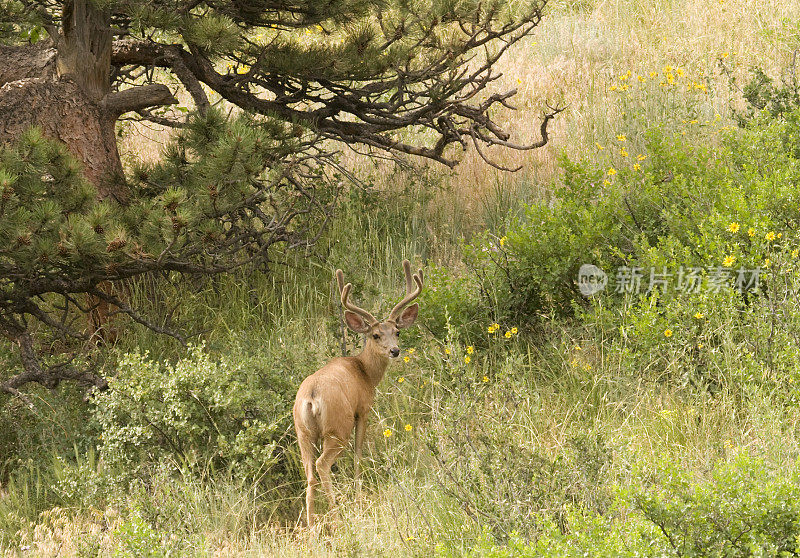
(0, 0), (800, 557)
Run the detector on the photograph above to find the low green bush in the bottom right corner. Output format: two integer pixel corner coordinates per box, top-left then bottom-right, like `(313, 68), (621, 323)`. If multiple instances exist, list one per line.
(460, 452), (800, 558)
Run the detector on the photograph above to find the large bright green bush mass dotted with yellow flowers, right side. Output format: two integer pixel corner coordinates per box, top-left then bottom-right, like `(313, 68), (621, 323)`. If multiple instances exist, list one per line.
(456, 111), (800, 387)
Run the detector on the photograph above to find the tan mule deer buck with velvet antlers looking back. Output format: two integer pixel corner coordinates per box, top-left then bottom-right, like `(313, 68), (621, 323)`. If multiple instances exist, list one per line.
(292, 260), (422, 527)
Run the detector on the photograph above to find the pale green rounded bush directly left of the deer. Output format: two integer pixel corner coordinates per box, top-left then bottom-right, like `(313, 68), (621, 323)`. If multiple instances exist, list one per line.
(94, 346), (289, 486)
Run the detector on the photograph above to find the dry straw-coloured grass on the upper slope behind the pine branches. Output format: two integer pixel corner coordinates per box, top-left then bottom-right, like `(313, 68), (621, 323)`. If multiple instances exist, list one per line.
(122, 0), (800, 228)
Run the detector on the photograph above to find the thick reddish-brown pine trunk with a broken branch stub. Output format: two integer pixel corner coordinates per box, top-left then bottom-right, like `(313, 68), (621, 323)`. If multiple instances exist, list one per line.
(0, 0), (176, 203)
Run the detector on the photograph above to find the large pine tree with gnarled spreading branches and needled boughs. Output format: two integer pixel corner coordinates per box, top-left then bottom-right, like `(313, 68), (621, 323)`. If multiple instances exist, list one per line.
(0, 0), (558, 394)
